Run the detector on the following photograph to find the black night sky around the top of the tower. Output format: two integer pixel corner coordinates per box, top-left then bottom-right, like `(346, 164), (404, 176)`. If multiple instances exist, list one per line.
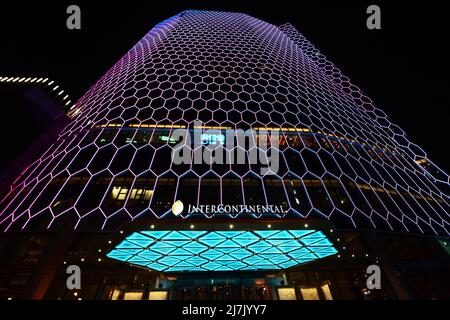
(0, 0), (450, 172)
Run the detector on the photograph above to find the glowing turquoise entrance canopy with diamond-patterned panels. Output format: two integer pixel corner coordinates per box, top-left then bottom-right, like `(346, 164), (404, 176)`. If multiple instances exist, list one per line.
(107, 230), (337, 272)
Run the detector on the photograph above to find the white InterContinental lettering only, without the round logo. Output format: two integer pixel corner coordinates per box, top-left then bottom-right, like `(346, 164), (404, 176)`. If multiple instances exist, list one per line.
(188, 204), (287, 214)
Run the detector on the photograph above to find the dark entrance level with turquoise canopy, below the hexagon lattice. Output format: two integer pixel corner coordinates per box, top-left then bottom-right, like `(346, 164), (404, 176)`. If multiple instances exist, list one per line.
(0, 220), (450, 300)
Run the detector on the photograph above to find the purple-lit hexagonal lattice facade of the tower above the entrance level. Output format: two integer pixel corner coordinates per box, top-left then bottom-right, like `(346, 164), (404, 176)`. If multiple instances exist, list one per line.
(0, 11), (450, 235)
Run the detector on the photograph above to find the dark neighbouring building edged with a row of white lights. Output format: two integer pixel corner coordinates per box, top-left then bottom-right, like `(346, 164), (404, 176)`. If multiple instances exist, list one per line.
(0, 75), (73, 195)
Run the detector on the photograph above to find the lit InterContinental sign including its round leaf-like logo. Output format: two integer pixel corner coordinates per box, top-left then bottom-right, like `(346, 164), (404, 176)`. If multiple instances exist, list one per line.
(172, 200), (287, 215)
